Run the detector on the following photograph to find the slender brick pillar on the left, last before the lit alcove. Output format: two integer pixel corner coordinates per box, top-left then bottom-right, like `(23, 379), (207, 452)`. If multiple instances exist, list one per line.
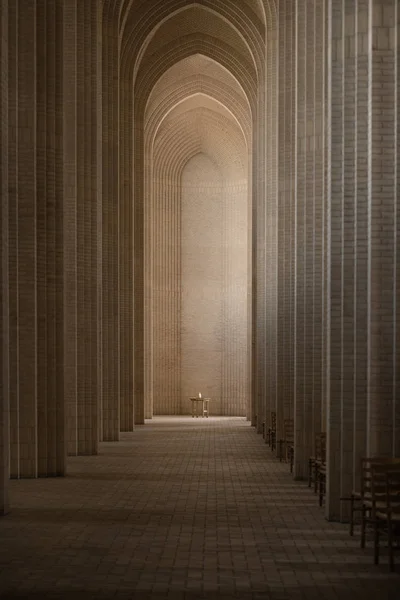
(118, 62), (140, 422)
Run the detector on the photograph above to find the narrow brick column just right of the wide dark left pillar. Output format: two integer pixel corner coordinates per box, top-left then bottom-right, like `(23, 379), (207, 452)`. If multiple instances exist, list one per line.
(76, 0), (100, 454)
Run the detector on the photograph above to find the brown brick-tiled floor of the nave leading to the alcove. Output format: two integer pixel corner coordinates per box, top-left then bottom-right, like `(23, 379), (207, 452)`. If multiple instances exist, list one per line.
(0, 417), (400, 600)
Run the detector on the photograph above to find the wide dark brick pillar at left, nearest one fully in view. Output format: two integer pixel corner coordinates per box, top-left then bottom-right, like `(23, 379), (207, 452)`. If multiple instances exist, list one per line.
(8, 0), (66, 477)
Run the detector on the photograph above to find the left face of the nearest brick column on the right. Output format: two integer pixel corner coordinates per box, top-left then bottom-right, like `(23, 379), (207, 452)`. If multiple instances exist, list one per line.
(326, 0), (357, 519)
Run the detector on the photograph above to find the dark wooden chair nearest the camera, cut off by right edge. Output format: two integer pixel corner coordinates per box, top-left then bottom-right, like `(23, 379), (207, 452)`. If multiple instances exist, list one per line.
(371, 462), (400, 571)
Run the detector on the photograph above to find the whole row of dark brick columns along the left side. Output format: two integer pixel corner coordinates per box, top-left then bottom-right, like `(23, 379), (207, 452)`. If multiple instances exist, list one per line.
(0, 0), (141, 507)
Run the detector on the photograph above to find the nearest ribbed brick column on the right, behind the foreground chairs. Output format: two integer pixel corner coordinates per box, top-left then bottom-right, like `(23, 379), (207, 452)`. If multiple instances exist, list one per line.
(327, 0), (400, 516)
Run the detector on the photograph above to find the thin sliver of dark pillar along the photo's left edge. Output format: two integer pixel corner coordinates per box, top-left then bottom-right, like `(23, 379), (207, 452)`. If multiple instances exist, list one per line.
(0, 0), (9, 515)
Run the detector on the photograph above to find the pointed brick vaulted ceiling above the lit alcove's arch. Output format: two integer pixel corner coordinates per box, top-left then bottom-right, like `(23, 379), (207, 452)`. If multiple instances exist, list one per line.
(114, 0), (265, 109)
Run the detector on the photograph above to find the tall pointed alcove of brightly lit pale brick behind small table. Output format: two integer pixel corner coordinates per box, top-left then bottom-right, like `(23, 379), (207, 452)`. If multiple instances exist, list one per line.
(145, 55), (251, 418)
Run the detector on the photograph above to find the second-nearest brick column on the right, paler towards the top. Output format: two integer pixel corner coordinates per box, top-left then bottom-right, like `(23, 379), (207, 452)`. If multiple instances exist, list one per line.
(294, 0), (326, 479)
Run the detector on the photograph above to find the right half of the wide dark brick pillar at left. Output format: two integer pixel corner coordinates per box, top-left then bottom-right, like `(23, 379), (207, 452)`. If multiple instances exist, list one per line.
(35, 0), (66, 476)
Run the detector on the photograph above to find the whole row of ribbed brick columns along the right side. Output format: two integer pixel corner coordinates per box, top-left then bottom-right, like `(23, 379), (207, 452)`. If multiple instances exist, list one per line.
(257, 0), (400, 518)
